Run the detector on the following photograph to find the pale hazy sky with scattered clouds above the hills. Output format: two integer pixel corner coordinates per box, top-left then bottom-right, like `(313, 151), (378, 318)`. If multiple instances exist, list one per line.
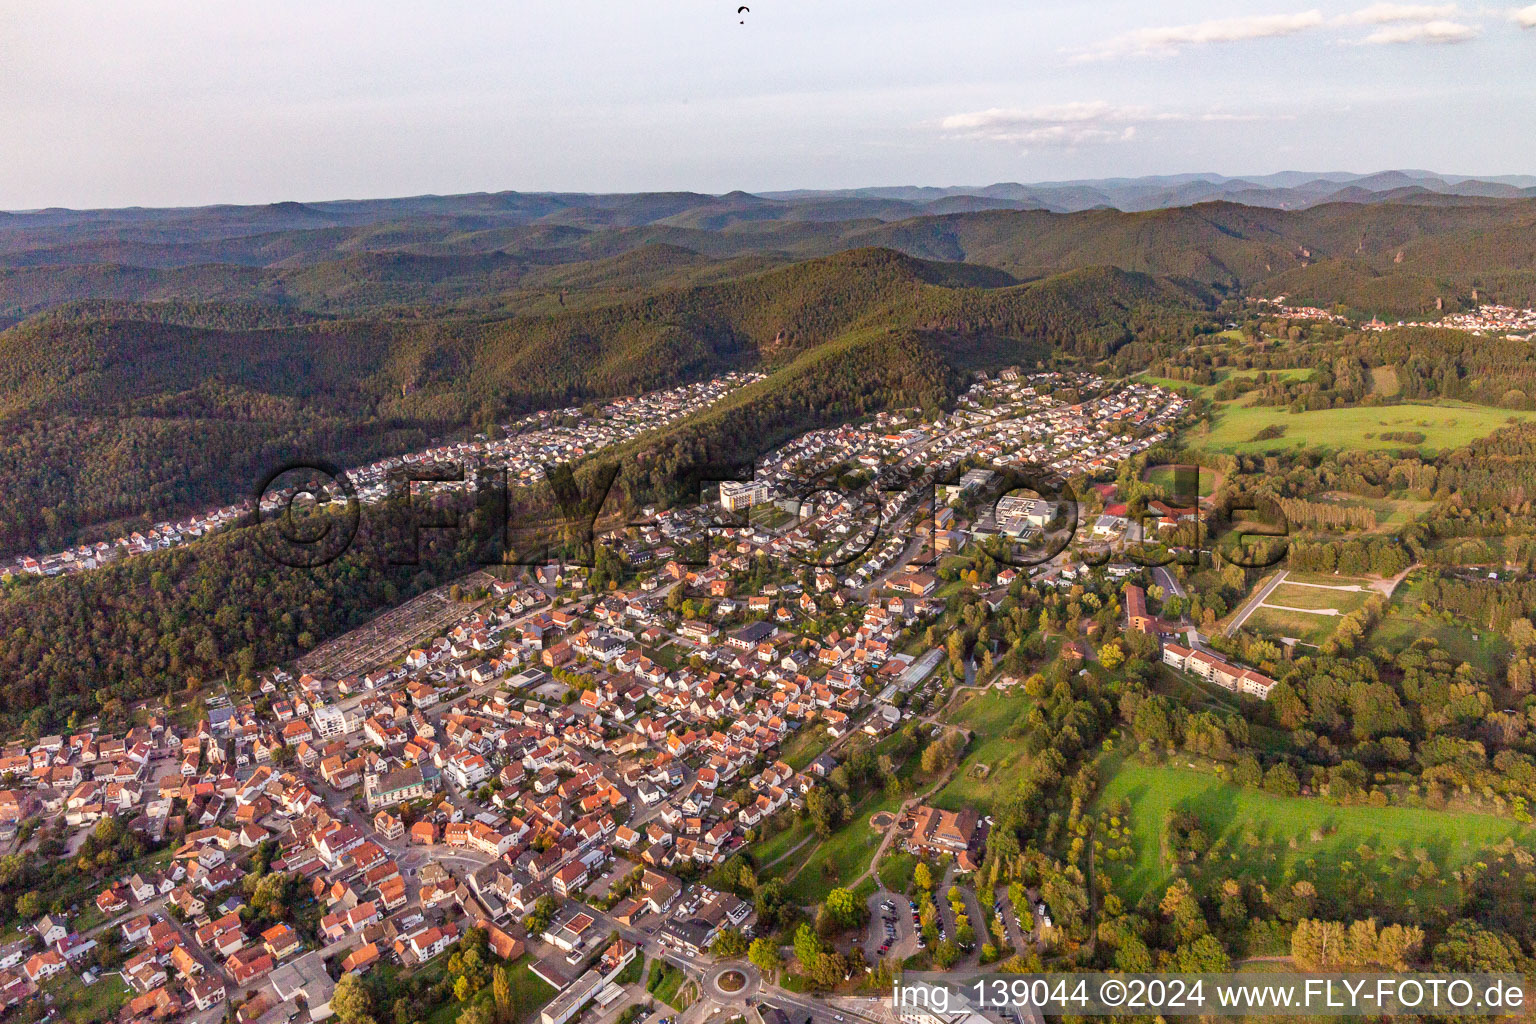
(0, 0), (1536, 210)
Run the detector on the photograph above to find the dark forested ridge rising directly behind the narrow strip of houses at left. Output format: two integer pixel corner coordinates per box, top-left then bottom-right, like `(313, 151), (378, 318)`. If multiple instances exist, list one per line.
(0, 250), (1204, 553)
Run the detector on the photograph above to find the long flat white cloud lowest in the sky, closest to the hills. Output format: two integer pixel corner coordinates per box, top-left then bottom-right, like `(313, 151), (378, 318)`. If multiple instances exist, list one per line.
(940, 100), (1264, 149)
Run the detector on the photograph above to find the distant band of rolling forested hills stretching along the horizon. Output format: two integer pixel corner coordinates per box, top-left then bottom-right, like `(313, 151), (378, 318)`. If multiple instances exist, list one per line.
(0, 193), (1536, 322)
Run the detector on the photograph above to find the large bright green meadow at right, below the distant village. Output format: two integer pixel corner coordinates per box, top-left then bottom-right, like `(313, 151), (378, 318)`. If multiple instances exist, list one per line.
(1187, 402), (1536, 453)
